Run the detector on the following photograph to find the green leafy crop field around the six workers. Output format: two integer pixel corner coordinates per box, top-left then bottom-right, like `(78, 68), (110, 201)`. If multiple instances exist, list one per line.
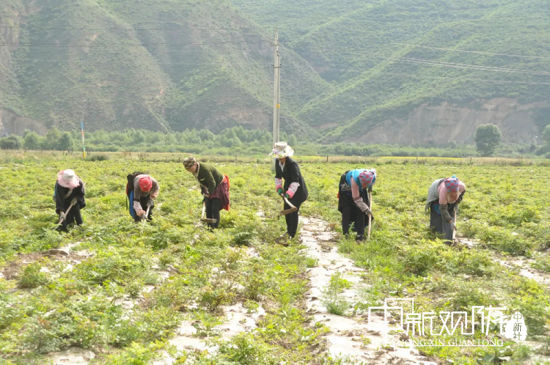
(0, 152), (550, 364)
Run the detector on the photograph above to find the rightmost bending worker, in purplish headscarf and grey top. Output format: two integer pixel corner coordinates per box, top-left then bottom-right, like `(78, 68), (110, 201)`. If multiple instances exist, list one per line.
(426, 175), (466, 244)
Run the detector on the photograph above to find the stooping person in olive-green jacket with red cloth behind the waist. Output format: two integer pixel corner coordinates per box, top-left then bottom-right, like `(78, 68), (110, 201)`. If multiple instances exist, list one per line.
(183, 157), (230, 228)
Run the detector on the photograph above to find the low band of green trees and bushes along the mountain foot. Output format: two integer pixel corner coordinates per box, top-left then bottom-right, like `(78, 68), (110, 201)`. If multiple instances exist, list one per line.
(0, 124), (550, 158)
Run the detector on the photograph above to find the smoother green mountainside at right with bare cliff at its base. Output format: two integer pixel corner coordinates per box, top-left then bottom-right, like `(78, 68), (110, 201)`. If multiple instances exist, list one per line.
(233, 0), (550, 144)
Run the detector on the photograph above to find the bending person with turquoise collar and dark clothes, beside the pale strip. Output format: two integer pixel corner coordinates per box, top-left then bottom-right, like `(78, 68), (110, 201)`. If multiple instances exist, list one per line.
(338, 169), (376, 241)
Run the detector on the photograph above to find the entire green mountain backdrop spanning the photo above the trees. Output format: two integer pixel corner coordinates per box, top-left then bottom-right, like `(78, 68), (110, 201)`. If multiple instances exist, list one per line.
(0, 0), (550, 145)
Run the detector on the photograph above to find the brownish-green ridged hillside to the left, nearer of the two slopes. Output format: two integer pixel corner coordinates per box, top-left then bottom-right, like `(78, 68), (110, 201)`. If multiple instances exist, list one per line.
(0, 0), (323, 138)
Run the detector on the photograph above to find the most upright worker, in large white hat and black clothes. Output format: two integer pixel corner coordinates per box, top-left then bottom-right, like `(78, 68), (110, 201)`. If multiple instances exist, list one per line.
(271, 142), (308, 241)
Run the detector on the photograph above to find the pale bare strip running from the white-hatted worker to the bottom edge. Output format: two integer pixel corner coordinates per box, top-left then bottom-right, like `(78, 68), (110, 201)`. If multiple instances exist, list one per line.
(301, 217), (436, 364)
